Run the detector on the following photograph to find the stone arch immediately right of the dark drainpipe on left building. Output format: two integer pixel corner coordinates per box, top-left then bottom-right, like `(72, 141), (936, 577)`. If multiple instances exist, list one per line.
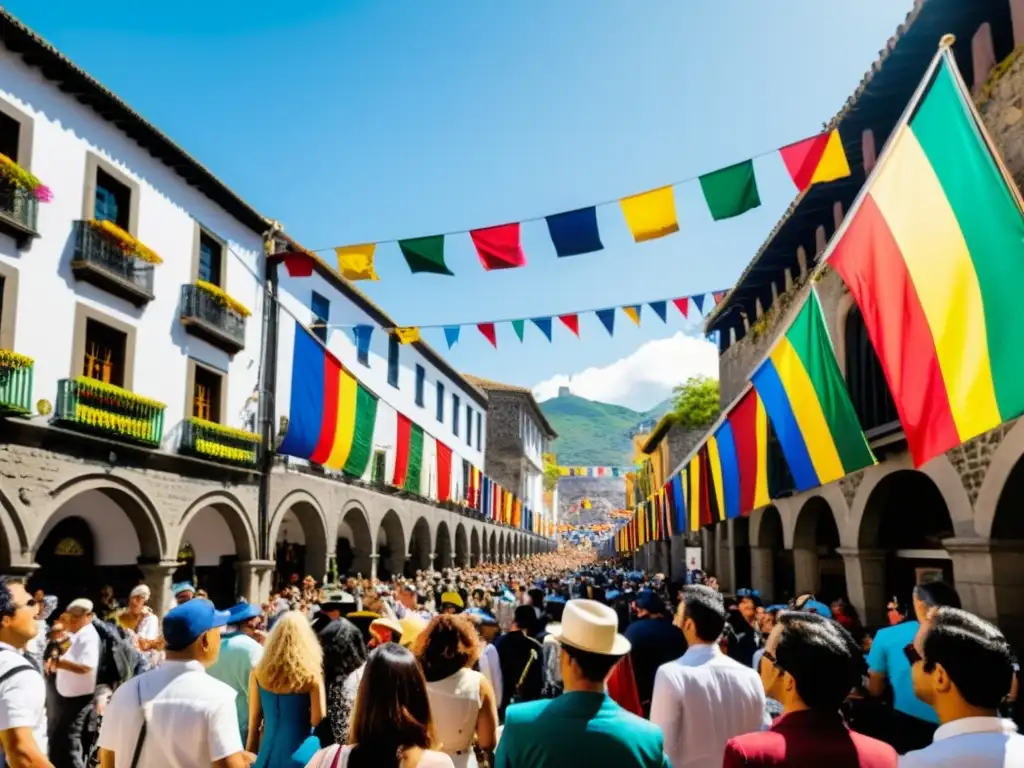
(267, 489), (329, 581)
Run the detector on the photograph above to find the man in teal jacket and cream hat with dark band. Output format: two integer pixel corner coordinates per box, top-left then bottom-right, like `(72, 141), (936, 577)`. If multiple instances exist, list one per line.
(495, 600), (671, 768)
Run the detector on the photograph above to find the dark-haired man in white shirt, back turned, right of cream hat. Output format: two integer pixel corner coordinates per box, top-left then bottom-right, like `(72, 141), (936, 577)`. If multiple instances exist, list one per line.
(650, 585), (767, 768)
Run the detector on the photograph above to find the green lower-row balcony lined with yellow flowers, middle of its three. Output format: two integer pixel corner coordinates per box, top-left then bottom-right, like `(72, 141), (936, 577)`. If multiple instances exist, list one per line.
(53, 376), (166, 445)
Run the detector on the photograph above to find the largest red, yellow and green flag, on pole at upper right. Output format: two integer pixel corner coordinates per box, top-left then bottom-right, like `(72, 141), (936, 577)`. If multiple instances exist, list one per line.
(830, 48), (1024, 466)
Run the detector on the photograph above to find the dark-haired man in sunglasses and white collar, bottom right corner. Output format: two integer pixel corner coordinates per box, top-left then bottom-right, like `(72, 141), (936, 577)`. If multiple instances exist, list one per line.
(899, 607), (1024, 768)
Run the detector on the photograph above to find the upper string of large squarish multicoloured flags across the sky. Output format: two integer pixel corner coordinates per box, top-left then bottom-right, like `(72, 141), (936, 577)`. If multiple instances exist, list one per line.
(292, 130), (850, 281)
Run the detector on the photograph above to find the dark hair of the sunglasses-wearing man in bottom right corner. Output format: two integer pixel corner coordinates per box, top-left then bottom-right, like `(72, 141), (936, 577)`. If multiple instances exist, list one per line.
(922, 606), (1014, 710)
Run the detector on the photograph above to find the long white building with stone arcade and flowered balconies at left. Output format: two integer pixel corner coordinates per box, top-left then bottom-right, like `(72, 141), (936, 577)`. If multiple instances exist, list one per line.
(0, 10), (549, 607)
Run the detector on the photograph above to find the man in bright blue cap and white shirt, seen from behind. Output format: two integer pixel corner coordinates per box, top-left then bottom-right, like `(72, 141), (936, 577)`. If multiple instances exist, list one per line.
(98, 600), (255, 768)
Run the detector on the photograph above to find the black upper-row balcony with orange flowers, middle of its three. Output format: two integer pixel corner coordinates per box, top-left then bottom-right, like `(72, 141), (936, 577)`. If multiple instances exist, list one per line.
(71, 221), (159, 306)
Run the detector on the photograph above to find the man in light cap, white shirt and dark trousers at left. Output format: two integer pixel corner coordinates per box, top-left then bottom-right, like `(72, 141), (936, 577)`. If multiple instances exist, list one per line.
(50, 598), (100, 768)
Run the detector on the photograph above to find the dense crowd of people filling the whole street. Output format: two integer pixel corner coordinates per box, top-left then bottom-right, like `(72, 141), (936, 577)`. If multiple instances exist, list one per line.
(0, 549), (1024, 768)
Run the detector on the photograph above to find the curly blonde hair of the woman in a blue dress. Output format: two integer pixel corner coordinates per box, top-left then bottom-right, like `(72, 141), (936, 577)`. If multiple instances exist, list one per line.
(253, 610), (324, 693)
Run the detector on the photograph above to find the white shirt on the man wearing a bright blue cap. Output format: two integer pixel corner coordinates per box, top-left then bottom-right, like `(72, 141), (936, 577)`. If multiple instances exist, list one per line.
(99, 660), (242, 768)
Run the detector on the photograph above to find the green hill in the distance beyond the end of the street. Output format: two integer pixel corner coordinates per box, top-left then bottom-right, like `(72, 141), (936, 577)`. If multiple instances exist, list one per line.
(541, 394), (672, 466)
